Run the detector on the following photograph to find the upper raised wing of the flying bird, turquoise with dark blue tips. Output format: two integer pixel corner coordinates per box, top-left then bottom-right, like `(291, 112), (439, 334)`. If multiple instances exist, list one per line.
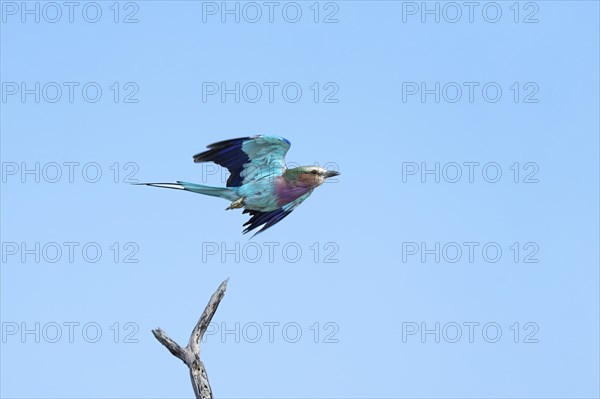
(194, 135), (291, 187)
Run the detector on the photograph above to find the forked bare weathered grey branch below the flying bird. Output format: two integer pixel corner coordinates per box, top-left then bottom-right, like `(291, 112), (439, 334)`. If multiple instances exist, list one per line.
(152, 279), (229, 399)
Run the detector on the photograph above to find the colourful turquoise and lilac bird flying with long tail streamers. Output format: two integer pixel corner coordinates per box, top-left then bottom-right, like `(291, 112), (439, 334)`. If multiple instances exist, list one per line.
(141, 135), (339, 235)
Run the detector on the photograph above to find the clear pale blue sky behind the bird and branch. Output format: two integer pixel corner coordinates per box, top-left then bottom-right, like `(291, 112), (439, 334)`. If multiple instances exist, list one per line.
(0, 1), (600, 398)
